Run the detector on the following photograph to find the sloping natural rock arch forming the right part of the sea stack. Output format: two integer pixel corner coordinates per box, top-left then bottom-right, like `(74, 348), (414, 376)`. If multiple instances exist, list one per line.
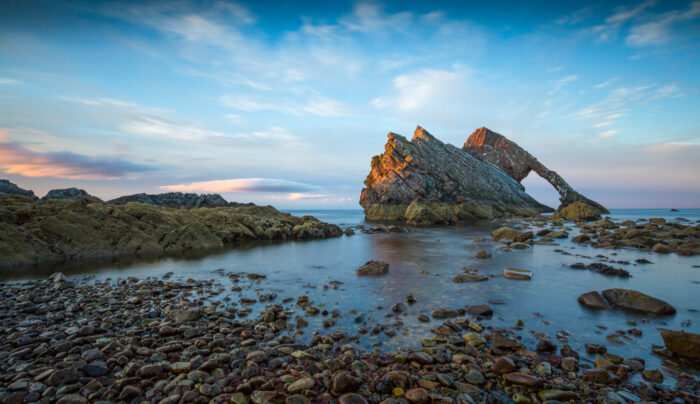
(462, 127), (608, 220)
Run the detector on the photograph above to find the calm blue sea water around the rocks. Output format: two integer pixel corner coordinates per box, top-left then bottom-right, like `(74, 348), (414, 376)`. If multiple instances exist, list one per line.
(1, 209), (700, 382)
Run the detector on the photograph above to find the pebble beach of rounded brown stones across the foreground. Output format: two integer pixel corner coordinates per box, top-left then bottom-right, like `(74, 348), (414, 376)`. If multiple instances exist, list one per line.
(0, 270), (700, 404)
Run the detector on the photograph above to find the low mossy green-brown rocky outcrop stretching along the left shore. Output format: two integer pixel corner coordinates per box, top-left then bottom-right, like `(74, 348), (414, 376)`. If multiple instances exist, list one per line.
(0, 195), (342, 270)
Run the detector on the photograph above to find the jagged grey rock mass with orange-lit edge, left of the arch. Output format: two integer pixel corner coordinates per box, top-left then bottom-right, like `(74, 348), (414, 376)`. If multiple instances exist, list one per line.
(360, 127), (551, 225)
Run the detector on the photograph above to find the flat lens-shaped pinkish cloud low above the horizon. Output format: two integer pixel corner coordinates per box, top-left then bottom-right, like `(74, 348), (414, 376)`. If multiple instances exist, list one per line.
(160, 178), (321, 194)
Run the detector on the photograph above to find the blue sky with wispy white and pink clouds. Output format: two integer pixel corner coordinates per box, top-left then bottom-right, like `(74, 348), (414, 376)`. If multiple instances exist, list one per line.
(0, 0), (700, 209)
